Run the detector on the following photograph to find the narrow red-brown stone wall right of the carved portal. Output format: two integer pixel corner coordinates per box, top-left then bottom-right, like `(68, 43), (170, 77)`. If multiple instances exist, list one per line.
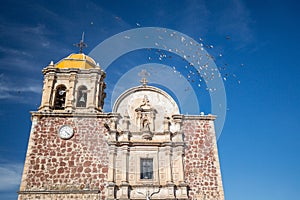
(182, 116), (224, 200)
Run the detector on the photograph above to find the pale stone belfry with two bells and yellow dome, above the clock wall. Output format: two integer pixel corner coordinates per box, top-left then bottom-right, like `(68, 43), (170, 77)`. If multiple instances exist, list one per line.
(39, 53), (106, 113)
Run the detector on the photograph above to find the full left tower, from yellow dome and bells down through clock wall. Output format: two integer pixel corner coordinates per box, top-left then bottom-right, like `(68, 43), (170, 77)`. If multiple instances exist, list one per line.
(18, 52), (113, 200)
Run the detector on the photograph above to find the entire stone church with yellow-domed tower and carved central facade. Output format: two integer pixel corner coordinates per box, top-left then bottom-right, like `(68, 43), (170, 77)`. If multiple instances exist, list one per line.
(18, 48), (224, 200)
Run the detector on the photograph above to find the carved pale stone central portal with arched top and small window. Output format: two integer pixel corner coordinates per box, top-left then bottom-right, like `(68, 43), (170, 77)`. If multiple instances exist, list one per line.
(109, 85), (188, 199)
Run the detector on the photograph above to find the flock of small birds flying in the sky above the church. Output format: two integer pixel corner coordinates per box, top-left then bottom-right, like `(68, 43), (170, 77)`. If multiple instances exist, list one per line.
(117, 22), (244, 92)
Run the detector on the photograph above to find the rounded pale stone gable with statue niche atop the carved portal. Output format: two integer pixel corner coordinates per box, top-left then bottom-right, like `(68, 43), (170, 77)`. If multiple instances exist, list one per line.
(113, 86), (180, 133)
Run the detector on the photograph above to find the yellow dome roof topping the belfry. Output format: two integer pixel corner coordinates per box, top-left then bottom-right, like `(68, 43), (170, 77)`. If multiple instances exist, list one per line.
(55, 53), (96, 69)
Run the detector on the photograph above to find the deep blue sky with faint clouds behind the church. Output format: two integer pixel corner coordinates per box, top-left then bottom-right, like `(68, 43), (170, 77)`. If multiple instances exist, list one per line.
(0, 0), (300, 200)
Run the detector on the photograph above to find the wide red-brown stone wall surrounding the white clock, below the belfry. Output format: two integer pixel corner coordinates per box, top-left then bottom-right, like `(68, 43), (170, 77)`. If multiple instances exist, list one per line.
(19, 115), (108, 200)
